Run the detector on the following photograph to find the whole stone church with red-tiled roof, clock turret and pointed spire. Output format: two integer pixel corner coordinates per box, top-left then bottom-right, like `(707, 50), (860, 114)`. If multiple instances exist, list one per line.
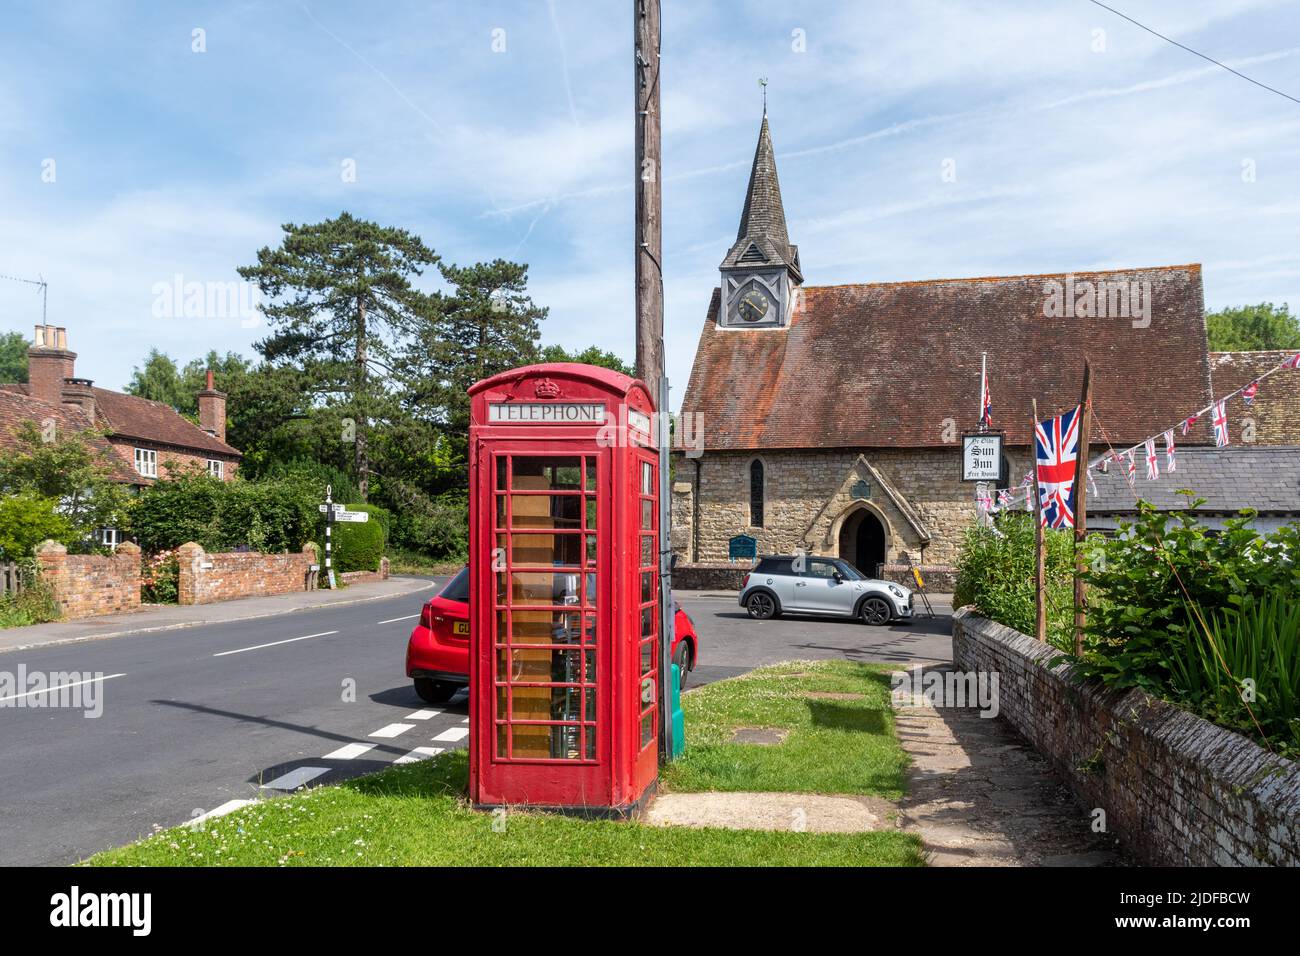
(672, 112), (1300, 589)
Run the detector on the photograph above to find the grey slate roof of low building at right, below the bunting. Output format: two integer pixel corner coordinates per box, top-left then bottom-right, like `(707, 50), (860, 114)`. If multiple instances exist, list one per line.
(1088, 447), (1300, 516)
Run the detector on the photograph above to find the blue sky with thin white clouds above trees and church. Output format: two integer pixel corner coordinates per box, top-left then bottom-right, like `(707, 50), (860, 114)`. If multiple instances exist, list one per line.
(0, 0), (1300, 405)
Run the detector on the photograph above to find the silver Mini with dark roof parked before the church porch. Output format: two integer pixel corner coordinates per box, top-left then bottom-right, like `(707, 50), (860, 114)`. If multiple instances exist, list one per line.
(740, 557), (913, 624)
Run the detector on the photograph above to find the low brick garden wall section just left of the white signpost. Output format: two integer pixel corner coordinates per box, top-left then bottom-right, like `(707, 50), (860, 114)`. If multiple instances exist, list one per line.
(177, 541), (317, 605)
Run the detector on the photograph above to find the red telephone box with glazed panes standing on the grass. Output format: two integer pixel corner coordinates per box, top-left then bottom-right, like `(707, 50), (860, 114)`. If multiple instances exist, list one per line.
(469, 363), (660, 816)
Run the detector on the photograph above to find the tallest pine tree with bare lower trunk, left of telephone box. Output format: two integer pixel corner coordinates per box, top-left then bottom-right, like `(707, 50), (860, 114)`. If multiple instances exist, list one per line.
(239, 212), (438, 502)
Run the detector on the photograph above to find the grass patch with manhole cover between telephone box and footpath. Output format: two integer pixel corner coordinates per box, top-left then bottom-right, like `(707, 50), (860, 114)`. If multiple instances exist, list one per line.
(663, 661), (909, 799)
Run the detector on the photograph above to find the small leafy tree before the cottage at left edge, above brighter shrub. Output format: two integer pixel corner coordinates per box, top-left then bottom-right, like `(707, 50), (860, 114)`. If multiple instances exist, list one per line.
(0, 421), (130, 549)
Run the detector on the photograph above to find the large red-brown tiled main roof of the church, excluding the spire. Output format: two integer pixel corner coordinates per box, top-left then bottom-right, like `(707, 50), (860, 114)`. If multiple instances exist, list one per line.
(683, 264), (1218, 450)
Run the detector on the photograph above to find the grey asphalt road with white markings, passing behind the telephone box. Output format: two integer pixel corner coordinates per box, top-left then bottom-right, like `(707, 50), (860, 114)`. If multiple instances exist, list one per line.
(0, 574), (949, 865)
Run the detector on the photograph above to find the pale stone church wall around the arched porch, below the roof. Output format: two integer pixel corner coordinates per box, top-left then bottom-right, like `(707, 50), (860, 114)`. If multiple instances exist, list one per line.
(672, 445), (1028, 566)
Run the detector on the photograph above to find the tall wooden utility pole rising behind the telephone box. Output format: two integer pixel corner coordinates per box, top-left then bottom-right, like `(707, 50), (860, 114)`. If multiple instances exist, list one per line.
(632, 0), (666, 385)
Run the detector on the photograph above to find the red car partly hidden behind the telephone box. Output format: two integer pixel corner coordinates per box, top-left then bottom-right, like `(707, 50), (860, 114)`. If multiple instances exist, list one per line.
(407, 567), (699, 704)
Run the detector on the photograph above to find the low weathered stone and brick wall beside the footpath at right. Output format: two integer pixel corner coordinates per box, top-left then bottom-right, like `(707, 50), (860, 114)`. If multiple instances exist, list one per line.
(953, 609), (1300, 866)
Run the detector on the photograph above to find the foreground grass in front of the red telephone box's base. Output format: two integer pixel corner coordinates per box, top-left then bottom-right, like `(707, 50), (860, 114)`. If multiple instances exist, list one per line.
(87, 750), (922, 866)
